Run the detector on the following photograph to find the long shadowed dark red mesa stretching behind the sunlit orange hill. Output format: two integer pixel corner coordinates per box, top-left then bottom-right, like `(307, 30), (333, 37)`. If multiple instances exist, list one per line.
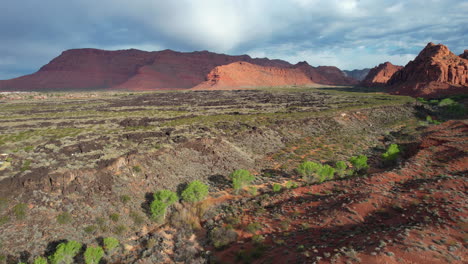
(0, 49), (356, 91)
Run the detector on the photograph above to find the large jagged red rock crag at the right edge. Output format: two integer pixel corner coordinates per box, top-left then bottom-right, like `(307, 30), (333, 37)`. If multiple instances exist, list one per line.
(387, 43), (468, 97)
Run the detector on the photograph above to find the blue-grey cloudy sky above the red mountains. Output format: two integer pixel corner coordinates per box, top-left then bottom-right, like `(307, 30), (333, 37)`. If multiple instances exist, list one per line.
(0, 0), (468, 79)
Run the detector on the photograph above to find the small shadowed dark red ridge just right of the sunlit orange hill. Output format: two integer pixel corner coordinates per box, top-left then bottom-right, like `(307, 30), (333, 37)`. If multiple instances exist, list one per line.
(293, 61), (358, 85)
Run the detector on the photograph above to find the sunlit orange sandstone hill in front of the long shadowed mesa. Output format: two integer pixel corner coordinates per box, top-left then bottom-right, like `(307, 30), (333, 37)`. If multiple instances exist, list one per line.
(190, 61), (313, 90)
